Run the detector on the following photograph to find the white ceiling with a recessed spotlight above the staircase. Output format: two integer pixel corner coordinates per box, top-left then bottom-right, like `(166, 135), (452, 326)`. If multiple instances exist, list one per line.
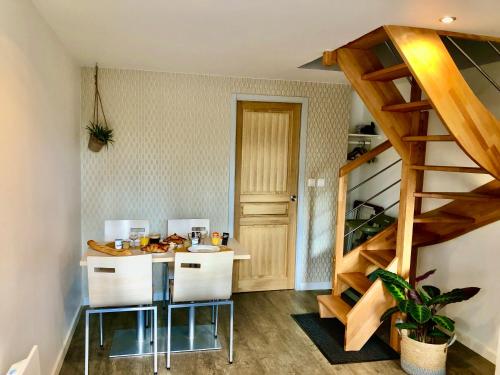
(33, 0), (500, 82)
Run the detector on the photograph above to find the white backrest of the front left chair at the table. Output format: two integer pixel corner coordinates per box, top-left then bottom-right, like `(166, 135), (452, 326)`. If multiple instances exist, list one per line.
(87, 254), (153, 307)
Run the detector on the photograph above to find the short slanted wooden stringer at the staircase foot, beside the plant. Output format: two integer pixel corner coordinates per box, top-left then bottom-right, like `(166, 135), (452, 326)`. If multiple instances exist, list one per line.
(344, 258), (397, 351)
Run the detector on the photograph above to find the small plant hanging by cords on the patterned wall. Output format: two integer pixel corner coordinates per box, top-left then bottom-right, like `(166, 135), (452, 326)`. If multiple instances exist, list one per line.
(86, 64), (114, 152)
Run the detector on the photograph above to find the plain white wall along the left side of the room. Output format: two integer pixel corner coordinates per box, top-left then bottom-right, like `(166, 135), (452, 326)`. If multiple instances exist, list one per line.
(0, 0), (81, 374)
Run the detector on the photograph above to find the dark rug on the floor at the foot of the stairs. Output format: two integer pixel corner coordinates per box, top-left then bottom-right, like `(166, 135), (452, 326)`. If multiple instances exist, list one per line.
(292, 313), (399, 365)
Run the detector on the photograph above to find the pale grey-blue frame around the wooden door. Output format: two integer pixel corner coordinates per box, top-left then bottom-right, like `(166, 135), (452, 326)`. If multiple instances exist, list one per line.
(228, 94), (309, 290)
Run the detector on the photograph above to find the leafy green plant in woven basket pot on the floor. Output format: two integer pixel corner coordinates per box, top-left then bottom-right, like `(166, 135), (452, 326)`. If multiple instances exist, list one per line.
(375, 269), (479, 375)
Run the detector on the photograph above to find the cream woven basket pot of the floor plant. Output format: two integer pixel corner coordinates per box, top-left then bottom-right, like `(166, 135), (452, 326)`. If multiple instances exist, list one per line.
(401, 330), (451, 375)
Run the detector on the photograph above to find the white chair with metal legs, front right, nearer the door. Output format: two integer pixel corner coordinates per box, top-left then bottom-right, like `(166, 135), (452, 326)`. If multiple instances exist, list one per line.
(167, 251), (234, 369)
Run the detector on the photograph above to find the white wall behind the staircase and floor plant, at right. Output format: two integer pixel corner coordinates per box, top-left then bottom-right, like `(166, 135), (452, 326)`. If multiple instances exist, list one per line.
(418, 63), (500, 362)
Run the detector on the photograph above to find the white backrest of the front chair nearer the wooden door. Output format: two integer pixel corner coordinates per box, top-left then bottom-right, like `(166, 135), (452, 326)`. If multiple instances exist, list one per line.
(172, 251), (234, 302)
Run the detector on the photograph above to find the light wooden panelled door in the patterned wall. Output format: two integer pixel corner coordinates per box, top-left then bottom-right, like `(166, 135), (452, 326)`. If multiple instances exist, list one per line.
(234, 102), (301, 292)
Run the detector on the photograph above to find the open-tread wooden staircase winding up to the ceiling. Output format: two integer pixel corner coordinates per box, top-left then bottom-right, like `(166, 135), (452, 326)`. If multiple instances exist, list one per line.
(318, 26), (500, 350)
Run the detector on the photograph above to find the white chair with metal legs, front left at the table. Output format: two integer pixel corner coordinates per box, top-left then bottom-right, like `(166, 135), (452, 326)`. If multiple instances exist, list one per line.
(85, 254), (158, 375)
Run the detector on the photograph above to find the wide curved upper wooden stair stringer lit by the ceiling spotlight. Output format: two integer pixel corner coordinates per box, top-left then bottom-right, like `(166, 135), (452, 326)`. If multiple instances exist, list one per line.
(384, 25), (500, 179)
